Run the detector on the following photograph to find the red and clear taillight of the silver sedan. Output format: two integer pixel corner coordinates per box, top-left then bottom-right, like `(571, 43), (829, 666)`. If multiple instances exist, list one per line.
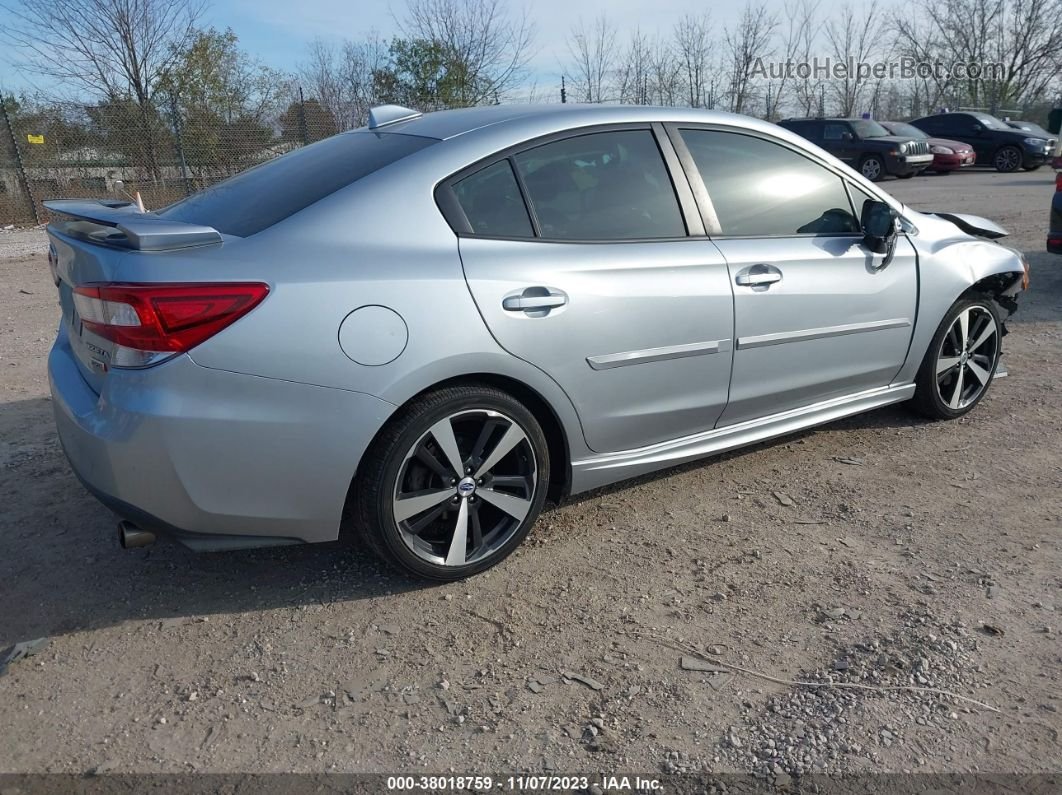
(73, 282), (269, 367)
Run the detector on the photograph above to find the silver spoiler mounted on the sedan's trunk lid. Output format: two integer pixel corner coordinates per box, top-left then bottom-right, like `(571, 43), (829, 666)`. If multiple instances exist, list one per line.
(45, 198), (222, 252)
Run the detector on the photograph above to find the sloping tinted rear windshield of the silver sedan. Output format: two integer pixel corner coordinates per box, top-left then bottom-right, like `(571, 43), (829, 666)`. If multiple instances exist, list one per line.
(158, 133), (436, 238)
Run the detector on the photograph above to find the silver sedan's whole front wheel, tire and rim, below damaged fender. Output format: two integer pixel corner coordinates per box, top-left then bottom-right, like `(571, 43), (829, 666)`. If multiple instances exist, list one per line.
(911, 295), (1003, 419)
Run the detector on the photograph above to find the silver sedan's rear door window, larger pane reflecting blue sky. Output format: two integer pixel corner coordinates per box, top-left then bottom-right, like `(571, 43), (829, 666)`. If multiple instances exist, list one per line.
(513, 129), (686, 241)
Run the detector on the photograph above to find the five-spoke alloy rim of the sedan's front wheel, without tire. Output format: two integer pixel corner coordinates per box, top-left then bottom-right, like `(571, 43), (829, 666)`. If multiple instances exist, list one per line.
(937, 306), (999, 410)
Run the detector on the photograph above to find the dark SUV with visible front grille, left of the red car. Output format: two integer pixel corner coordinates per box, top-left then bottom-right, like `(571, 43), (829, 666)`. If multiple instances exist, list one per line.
(778, 119), (932, 182)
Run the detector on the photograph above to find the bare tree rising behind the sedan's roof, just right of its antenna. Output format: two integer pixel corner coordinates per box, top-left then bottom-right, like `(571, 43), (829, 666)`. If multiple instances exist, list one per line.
(400, 0), (534, 105)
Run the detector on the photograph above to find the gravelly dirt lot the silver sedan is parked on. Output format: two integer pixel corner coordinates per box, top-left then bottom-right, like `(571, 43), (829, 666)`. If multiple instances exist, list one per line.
(0, 170), (1062, 782)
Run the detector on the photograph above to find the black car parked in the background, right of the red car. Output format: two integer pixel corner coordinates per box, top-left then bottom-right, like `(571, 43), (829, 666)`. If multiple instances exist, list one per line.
(911, 113), (1055, 171)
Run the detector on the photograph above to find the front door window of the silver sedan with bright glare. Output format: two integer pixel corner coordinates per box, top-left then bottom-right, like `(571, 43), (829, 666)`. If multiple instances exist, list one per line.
(682, 129), (859, 237)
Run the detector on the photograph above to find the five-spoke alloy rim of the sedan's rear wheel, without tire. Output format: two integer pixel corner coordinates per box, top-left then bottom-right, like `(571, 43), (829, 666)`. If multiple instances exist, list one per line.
(392, 409), (538, 567)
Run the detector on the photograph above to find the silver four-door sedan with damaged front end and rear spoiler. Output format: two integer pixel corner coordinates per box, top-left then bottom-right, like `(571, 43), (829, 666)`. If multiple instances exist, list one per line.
(49, 105), (1027, 580)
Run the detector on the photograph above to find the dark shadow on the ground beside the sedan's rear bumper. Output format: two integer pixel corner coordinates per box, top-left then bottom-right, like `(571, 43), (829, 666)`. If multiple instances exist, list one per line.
(0, 398), (431, 647)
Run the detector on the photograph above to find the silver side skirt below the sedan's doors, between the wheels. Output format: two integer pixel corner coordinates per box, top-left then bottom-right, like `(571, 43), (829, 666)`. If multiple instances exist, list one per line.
(571, 383), (914, 494)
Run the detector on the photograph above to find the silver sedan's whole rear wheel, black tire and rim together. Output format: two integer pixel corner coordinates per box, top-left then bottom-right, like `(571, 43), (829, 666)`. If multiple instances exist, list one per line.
(355, 384), (549, 581)
